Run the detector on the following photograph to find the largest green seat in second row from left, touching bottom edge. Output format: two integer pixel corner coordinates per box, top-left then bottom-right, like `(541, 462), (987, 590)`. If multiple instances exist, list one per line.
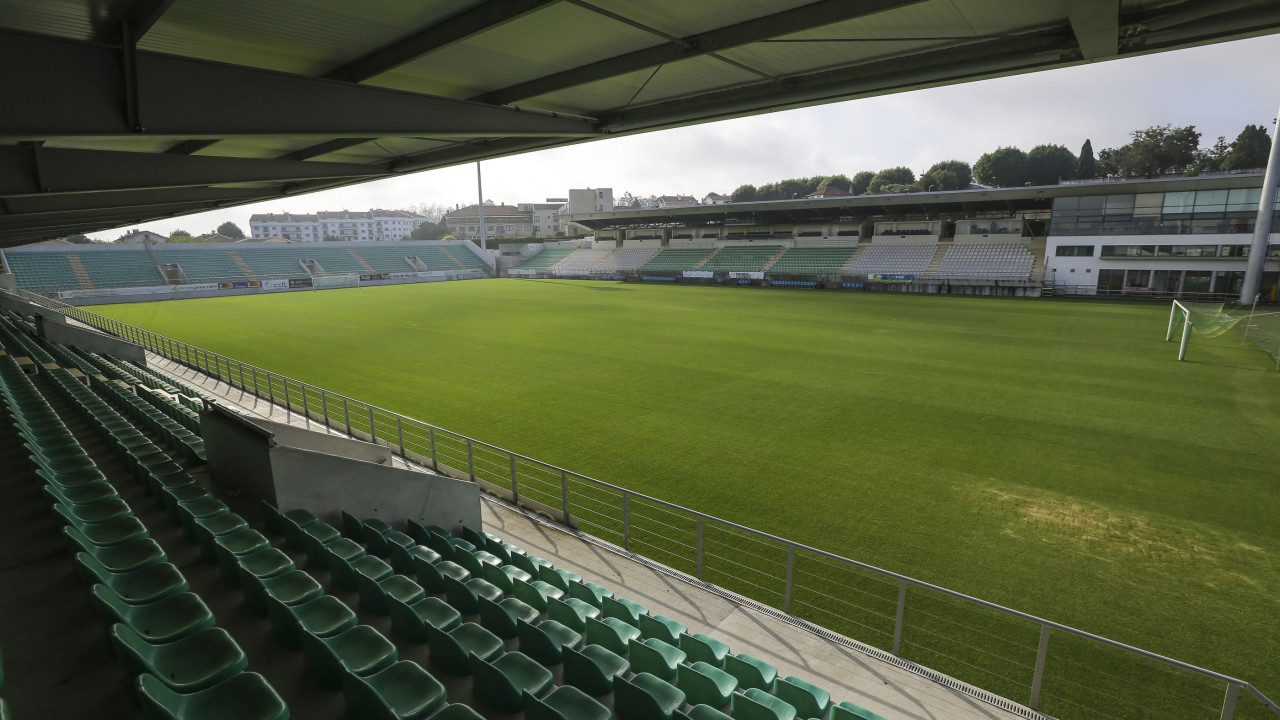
(342, 660), (445, 720)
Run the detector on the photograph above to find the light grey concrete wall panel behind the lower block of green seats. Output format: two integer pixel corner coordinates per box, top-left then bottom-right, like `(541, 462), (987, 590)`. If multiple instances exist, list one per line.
(270, 446), (483, 530)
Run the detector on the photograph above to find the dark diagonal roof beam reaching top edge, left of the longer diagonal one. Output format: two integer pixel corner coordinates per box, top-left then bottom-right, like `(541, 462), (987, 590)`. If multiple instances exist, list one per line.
(325, 0), (559, 82)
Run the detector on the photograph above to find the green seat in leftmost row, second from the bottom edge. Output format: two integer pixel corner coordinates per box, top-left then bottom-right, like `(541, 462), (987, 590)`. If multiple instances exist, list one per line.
(111, 624), (248, 693)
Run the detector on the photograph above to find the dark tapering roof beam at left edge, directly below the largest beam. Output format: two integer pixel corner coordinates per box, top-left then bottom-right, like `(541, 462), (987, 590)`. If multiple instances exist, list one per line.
(0, 145), (389, 197)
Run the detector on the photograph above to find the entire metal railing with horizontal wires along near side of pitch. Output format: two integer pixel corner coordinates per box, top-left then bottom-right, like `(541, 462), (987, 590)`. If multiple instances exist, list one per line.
(12, 285), (1280, 720)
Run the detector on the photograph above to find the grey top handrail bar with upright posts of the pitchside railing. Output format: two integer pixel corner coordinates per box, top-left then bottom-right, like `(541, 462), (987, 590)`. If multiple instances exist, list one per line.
(18, 290), (1280, 720)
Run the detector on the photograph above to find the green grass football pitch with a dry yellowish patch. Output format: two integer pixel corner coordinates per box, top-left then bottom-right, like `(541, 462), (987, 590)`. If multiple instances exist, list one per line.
(99, 281), (1280, 716)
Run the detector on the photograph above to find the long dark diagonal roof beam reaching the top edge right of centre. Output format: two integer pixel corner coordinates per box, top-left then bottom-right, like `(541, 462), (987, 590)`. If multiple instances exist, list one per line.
(472, 0), (923, 105)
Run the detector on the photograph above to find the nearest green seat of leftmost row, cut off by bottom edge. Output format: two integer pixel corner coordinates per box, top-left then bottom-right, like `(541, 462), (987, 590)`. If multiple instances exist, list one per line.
(134, 673), (289, 720)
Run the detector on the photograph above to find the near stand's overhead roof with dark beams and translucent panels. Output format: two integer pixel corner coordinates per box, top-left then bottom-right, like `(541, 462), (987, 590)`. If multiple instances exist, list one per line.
(0, 0), (1280, 246)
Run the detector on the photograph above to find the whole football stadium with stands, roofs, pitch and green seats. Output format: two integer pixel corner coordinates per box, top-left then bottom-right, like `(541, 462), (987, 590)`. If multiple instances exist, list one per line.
(0, 0), (1280, 720)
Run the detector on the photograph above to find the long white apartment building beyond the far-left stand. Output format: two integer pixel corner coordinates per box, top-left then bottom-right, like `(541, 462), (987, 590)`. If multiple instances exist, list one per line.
(248, 210), (426, 242)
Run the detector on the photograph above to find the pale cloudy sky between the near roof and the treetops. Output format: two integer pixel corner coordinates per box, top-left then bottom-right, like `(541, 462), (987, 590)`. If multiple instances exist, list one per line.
(91, 35), (1280, 240)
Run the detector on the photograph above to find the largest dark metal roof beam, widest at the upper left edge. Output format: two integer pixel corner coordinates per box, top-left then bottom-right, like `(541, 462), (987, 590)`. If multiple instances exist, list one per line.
(0, 32), (598, 140)
